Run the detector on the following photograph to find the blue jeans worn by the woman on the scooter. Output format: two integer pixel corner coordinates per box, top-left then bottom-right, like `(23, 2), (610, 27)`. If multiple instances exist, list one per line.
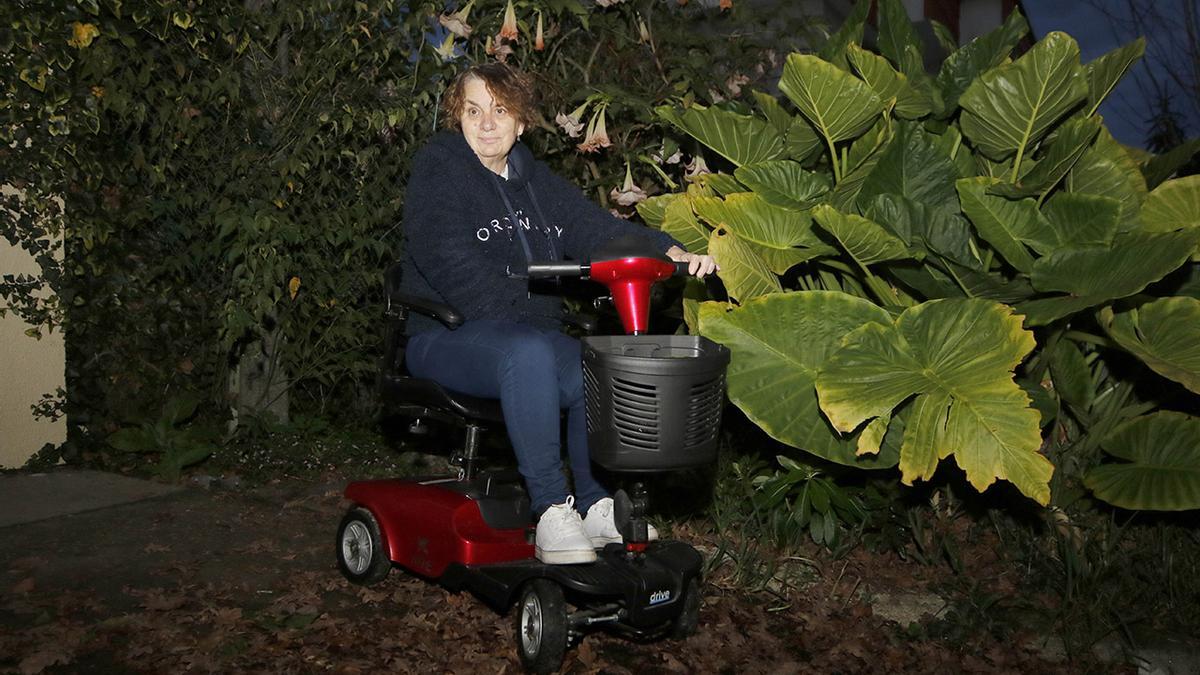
(404, 319), (608, 514)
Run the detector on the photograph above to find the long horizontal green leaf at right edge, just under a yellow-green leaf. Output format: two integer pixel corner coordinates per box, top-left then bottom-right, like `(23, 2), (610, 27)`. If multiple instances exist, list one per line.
(1018, 231), (1200, 325)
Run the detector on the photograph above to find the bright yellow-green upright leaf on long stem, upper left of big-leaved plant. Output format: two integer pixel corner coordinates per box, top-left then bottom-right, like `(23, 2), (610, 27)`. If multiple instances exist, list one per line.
(768, 54), (883, 148)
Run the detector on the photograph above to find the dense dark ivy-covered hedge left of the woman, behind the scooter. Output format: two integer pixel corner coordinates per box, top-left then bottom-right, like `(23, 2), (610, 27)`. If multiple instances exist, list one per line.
(4, 2), (415, 454)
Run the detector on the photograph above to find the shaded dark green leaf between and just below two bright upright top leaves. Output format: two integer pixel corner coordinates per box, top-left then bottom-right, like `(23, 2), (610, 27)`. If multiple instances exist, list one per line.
(859, 123), (959, 210)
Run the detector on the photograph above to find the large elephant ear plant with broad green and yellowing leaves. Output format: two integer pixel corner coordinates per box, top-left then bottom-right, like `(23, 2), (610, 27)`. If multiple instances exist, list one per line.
(640, 0), (1200, 509)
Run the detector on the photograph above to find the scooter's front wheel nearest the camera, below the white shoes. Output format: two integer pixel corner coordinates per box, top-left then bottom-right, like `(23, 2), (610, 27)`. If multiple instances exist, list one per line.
(515, 579), (568, 673)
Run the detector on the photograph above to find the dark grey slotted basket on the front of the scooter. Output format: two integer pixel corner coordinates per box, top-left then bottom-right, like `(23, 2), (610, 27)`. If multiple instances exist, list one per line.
(583, 335), (730, 472)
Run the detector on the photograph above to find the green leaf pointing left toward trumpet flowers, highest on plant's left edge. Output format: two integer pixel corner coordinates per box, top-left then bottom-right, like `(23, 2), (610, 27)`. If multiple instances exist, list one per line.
(658, 106), (784, 166)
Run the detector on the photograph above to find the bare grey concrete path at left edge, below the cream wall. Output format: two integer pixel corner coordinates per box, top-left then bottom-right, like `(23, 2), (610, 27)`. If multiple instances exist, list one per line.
(0, 468), (181, 527)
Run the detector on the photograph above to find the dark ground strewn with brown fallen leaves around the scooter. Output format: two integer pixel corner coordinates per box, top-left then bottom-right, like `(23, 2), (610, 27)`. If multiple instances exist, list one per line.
(0, 477), (1123, 674)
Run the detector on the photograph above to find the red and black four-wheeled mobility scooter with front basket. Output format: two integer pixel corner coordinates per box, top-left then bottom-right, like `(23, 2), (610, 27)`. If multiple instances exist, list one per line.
(337, 240), (730, 673)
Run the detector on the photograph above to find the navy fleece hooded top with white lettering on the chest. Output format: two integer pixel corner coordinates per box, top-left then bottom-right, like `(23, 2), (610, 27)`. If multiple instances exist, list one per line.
(401, 131), (679, 334)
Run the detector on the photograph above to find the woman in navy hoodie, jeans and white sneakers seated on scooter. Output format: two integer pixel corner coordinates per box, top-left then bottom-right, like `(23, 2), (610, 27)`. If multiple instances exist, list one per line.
(403, 64), (716, 565)
